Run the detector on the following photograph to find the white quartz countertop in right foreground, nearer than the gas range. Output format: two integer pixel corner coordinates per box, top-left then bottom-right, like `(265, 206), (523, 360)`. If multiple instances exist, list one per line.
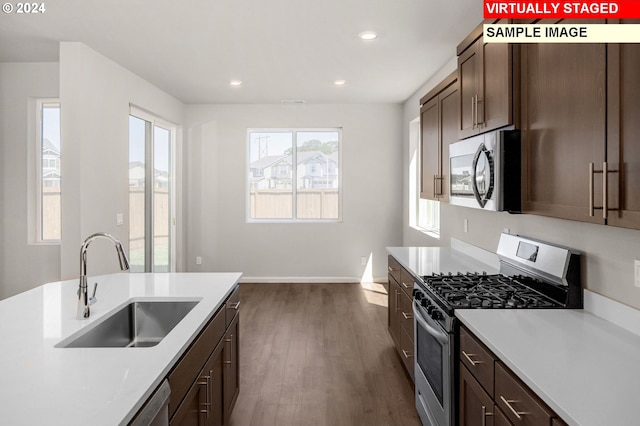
(455, 309), (640, 426)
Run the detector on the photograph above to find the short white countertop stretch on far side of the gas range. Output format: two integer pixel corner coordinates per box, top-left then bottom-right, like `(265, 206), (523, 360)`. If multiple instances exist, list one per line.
(387, 247), (498, 277)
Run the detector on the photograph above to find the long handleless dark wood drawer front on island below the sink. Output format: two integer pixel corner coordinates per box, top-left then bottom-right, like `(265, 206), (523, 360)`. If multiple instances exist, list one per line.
(168, 309), (225, 417)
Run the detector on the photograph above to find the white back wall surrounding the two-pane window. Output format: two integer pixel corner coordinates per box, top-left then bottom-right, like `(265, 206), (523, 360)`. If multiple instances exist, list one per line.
(185, 104), (402, 281)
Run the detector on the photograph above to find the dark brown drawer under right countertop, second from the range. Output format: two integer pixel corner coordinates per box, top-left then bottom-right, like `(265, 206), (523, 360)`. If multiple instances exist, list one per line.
(495, 362), (555, 426)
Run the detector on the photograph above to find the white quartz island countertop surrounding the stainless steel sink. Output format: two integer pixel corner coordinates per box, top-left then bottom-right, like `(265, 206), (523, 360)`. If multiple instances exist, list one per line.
(0, 273), (241, 426)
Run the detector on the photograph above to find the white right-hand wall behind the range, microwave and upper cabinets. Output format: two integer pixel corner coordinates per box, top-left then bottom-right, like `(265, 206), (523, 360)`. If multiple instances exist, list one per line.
(403, 58), (640, 309)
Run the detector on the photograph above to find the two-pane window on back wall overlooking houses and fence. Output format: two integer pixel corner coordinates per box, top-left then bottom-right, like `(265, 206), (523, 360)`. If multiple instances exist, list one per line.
(247, 129), (341, 222)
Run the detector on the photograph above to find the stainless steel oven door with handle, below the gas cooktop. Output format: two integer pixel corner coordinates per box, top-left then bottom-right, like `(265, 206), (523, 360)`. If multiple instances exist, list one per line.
(413, 301), (453, 426)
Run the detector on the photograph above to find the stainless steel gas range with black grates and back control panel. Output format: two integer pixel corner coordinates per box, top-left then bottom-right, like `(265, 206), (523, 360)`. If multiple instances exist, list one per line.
(413, 234), (582, 426)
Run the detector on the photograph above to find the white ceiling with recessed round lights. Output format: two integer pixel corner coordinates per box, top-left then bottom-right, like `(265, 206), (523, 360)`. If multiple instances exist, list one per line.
(0, 0), (482, 103)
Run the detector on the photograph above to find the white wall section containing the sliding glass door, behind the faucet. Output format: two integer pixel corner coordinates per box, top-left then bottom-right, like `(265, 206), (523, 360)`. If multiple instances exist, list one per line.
(60, 42), (184, 279)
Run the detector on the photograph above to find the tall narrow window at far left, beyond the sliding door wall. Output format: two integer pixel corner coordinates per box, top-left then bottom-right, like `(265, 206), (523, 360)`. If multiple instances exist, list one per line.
(36, 99), (62, 243)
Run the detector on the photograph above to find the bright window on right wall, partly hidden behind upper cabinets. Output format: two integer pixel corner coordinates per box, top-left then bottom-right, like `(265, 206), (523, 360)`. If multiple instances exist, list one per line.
(409, 118), (440, 236)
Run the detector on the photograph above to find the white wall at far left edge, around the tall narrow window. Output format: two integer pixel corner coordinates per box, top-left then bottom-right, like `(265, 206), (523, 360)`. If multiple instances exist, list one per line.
(0, 63), (60, 299)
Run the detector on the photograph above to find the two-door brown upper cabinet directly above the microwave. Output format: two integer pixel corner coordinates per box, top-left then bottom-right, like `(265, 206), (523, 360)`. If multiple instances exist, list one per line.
(457, 20), (518, 139)
